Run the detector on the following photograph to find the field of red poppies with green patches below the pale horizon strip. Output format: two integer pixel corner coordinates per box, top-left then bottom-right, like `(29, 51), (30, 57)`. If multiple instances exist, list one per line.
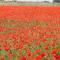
(0, 6), (60, 60)
